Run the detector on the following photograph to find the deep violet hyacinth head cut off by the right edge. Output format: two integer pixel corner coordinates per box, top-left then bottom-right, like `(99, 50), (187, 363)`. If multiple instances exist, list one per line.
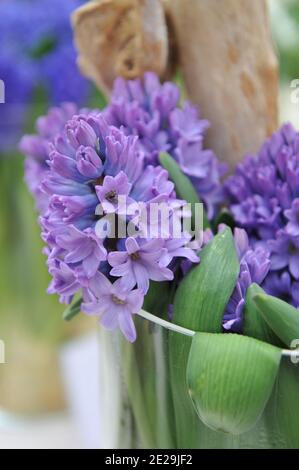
(225, 124), (299, 307)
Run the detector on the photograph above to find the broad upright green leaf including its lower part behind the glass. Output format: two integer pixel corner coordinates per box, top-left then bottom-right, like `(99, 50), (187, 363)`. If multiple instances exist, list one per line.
(169, 228), (239, 448)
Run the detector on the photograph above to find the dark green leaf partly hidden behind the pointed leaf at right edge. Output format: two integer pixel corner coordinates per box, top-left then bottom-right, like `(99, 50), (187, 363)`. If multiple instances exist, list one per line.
(243, 284), (281, 346)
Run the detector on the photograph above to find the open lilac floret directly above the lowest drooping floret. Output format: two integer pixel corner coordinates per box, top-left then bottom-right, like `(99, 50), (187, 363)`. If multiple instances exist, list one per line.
(108, 237), (173, 294)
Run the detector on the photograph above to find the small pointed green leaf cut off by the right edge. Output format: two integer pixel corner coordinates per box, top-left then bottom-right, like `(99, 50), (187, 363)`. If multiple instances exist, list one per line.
(253, 294), (299, 347)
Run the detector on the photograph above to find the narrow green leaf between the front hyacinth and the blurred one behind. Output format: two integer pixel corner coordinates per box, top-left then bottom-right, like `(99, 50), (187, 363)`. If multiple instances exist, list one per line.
(159, 152), (210, 229)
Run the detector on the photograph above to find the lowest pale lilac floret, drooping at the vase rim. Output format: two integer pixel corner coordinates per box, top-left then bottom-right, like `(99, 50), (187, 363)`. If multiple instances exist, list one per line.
(81, 273), (144, 342)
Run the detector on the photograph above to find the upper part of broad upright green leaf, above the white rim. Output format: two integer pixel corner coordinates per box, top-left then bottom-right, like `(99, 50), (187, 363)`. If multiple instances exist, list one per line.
(174, 228), (240, 333)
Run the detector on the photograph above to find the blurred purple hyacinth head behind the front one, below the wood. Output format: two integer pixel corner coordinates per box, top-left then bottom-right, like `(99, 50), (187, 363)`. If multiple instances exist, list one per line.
(105, 72), (225, 219)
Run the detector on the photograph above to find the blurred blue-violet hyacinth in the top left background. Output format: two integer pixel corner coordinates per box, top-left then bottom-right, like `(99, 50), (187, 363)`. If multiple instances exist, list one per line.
(0, 0), (90, 152)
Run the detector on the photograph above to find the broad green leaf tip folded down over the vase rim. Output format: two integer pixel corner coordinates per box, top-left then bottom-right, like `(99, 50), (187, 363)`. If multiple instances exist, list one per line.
(187, 333), (281, 435)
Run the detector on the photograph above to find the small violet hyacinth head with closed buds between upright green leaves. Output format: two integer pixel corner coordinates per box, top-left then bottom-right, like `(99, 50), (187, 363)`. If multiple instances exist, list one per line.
(204, 225), (270, 333)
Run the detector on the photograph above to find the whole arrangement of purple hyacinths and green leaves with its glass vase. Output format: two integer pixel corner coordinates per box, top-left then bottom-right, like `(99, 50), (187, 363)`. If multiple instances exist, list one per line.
(20, 0), (299, 448)
